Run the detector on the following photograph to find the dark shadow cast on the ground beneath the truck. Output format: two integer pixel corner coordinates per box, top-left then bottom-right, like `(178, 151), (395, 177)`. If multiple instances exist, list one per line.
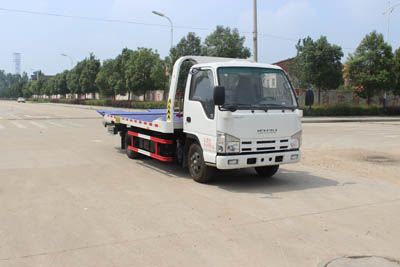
(123, 152), (341, 194)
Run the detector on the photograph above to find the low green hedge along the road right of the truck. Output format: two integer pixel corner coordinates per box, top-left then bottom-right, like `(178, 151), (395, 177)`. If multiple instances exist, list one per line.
(303, 105), (400, 116)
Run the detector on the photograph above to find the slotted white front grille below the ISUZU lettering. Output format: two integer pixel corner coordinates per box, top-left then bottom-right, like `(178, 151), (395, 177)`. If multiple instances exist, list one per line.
(240, 137), (289, 153)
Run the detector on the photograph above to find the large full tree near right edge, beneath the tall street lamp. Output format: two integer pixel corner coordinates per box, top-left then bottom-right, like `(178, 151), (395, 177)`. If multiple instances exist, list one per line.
(346, 31), (396, 105)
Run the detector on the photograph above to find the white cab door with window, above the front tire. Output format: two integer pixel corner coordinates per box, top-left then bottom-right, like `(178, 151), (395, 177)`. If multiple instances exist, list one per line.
(183, 68), (217, 163)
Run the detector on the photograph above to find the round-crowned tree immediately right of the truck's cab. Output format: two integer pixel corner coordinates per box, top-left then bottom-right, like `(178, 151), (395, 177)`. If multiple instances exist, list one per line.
(289, 36), (343, 104)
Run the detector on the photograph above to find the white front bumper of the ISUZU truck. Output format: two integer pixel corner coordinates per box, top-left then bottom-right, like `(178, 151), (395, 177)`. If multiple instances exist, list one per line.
(216, 150), (301, 170)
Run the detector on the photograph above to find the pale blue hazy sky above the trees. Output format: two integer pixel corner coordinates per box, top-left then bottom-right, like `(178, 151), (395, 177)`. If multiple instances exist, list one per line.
(0, 0), (400, 75)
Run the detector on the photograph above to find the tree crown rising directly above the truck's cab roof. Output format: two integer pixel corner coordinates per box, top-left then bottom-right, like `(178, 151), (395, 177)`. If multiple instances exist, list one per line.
(201, 26), (251, 58)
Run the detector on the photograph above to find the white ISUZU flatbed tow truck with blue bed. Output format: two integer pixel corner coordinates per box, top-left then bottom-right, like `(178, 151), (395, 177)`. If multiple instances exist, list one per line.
(98, 56), (302, 183)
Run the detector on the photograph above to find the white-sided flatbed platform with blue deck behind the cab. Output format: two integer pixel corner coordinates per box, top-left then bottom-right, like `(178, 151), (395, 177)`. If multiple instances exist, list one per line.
(97, 109), (183, 133)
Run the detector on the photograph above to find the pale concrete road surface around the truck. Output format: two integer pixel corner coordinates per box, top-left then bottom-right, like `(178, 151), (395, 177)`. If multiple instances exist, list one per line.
(0, 101), (400, 267)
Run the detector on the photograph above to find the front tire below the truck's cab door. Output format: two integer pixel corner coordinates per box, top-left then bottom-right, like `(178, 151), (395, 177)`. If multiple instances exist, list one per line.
(188, 143), (212, 183)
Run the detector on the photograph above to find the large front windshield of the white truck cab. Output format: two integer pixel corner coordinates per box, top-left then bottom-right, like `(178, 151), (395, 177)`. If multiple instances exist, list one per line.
(218, 67), (297, 109)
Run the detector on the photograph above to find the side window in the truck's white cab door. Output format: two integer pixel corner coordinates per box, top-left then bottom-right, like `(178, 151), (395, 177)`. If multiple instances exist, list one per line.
(189, 70), (215, 119)
